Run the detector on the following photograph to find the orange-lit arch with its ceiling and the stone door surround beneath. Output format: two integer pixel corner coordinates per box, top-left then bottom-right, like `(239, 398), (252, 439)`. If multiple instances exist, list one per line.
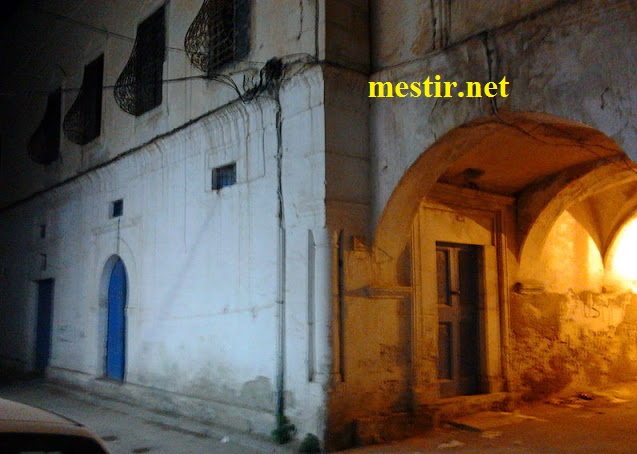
(373, 113), (637, 408)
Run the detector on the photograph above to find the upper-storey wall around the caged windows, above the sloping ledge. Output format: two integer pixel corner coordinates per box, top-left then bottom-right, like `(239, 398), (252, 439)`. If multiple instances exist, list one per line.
(0, 0), (324, 204)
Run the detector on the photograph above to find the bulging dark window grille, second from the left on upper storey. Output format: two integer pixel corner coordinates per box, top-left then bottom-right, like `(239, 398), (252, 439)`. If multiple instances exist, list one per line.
(62, 55), (104, 145)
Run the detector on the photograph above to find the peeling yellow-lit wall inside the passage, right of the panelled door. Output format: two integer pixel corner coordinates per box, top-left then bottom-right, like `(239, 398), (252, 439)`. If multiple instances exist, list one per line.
(511, 211), (637, 400)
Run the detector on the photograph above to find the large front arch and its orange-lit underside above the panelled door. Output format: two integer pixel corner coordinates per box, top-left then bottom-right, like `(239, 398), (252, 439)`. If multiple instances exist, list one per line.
(373, 112), (622, 286)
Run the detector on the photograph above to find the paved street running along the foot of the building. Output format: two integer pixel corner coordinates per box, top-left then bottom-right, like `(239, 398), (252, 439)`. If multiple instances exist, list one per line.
(0, 381), (637, 454)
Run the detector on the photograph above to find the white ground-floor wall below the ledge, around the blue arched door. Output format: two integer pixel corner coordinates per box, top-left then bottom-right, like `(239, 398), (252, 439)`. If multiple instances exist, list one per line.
(0, 66), (329, 432)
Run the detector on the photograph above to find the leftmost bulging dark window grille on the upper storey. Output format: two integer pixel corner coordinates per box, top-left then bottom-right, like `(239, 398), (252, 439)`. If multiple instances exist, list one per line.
(27, 88), (62, 165)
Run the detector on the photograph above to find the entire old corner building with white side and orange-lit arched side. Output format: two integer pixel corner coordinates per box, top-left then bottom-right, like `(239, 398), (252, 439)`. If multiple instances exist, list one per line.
(0, 0), (637, 449)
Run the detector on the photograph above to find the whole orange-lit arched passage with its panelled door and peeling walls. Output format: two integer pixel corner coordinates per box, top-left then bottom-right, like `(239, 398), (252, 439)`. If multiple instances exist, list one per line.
(332, 113), (637, 446)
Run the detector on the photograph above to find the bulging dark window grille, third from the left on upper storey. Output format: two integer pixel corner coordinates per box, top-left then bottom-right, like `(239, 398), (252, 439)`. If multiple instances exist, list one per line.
(114, 6), (166, 116)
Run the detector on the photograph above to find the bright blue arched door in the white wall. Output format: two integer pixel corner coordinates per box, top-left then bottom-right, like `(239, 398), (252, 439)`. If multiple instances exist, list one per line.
(106, 258), (128, 381)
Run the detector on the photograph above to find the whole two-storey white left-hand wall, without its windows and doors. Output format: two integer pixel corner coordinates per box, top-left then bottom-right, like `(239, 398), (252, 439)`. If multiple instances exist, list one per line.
(0, 0), (330, 435)
